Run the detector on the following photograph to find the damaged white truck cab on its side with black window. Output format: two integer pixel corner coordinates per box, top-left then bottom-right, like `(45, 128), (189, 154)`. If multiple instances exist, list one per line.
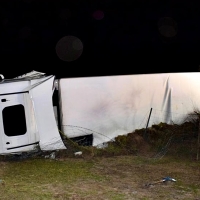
(0, 71), (66, 155)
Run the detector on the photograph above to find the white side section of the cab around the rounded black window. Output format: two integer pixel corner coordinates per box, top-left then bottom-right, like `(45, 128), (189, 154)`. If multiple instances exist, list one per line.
(0, 92), (38, 152)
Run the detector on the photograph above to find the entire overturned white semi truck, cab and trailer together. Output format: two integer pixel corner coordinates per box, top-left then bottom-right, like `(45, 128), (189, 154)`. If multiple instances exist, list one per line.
(0, 71), (200, 155)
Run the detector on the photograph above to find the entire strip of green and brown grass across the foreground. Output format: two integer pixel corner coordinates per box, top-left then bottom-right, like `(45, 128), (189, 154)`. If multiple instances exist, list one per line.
(0, 155), (200, 200)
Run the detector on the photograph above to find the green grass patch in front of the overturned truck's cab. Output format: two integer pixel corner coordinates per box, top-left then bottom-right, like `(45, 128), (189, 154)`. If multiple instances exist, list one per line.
(0, 159), (107, 199)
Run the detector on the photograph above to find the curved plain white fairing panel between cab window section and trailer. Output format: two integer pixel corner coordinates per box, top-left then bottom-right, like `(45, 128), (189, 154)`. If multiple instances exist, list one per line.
(30, 76), (66, 150)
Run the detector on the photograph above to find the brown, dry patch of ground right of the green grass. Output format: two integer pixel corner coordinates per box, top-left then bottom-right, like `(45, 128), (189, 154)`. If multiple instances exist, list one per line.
(72, 156), (200, 200)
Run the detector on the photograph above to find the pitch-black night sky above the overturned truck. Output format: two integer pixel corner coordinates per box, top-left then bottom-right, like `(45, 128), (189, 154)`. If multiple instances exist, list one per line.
(0, 0), (200, 78)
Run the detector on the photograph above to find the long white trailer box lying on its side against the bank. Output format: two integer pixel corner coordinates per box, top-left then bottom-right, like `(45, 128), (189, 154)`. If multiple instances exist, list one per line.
(58, 72), (200, 146)
